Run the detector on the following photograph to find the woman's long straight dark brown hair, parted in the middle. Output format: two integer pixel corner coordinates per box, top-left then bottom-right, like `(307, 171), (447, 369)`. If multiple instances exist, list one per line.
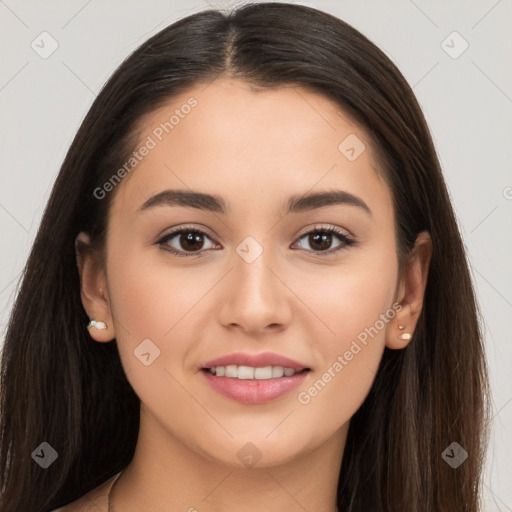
(0, 3), (488, 512)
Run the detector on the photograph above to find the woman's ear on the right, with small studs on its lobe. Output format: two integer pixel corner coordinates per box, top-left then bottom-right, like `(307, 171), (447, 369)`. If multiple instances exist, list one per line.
(386, 231), (432, 349)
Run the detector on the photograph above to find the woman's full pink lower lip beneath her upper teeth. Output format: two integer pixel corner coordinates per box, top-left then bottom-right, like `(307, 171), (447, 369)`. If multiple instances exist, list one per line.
(202, 370), (309, 405)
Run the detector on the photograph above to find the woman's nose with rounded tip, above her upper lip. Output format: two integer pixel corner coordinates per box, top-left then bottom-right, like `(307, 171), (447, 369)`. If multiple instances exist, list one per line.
(219, 247), (293, 335)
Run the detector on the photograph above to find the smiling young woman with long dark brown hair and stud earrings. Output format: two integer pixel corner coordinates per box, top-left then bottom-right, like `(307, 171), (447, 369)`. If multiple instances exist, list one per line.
(0, 3), (488, 512)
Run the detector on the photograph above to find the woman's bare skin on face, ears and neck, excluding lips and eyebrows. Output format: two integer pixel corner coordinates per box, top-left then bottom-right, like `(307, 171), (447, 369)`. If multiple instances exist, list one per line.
(75, 78), (432, 512)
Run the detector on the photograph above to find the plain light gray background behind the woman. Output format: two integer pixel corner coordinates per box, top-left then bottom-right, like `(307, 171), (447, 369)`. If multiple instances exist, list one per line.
(0, 0), (512, 511)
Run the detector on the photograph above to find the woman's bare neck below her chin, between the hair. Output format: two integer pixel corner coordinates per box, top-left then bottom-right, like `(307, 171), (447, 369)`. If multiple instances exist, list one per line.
(110, 407), (348, 512)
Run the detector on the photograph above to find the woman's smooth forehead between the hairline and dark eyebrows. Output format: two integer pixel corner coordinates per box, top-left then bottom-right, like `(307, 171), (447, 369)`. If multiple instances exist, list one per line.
(111, 79), (390, 217)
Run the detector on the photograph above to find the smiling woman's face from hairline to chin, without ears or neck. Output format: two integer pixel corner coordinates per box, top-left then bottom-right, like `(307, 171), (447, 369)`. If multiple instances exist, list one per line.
(86, 79), (406, 466)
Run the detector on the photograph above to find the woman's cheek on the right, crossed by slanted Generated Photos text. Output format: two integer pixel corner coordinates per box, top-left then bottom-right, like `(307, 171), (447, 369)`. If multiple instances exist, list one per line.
(298, 246), (397, 420)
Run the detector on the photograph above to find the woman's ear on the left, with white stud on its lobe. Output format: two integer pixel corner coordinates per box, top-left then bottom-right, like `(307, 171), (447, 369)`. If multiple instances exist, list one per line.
(75, 232), (115, 342)
